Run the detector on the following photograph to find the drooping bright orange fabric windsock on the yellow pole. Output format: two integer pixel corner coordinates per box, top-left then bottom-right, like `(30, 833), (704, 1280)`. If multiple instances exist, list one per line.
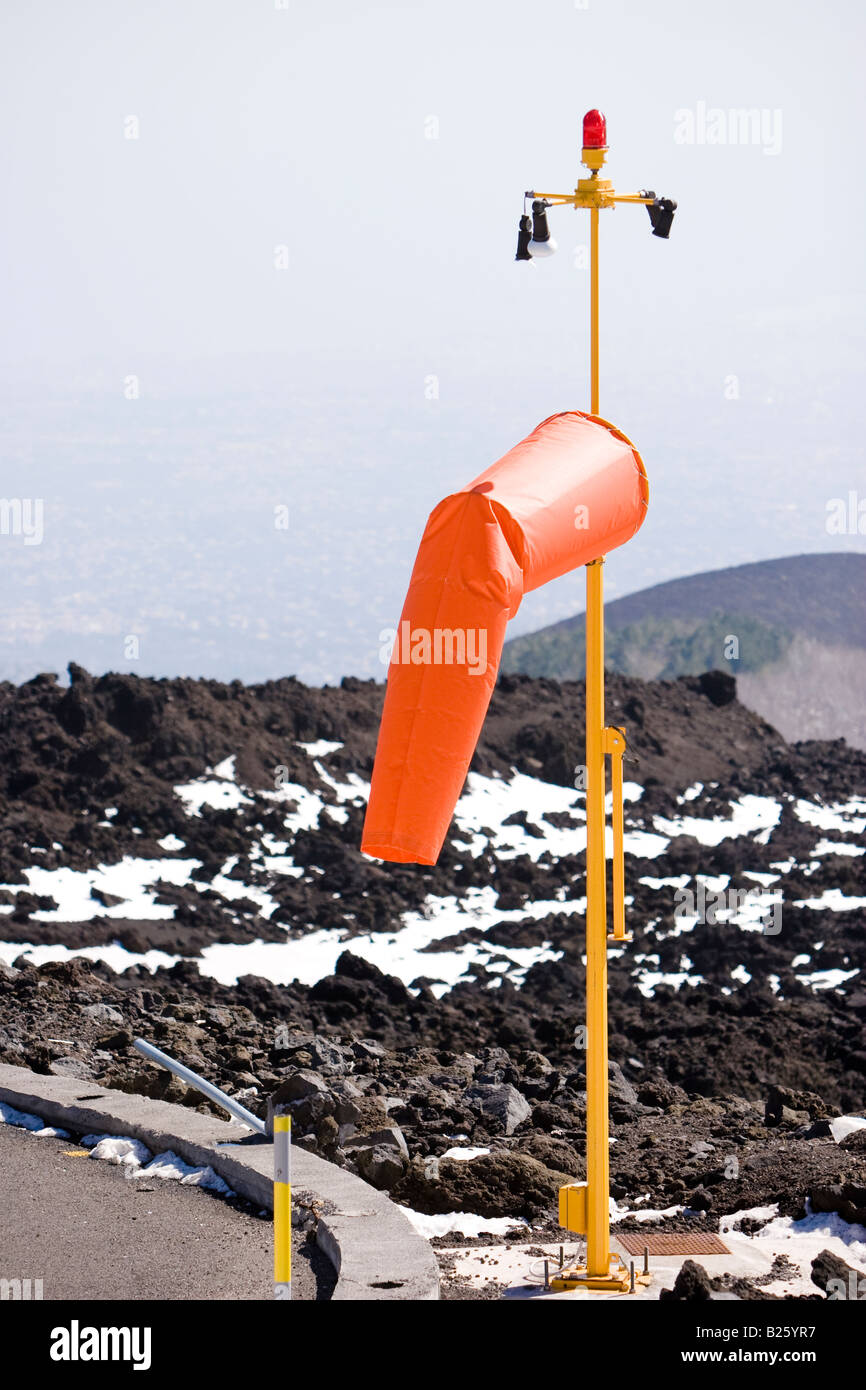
(361, 410), (648, 865)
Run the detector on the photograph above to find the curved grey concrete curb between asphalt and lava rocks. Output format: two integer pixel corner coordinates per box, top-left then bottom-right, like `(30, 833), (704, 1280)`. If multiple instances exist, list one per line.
(0, 1065), (439, 1302)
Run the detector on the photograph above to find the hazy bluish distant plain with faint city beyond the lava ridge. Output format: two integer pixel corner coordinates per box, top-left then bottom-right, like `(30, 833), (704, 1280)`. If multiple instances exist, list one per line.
(0, 358), (866, 684)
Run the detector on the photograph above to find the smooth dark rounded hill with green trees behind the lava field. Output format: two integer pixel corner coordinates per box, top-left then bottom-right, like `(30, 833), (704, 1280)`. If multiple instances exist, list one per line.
(502, 553), (866, 748)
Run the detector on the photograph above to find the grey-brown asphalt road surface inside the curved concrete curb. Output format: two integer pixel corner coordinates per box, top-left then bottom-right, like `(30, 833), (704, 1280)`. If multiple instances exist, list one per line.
(0, 1123), (329, 1300)
